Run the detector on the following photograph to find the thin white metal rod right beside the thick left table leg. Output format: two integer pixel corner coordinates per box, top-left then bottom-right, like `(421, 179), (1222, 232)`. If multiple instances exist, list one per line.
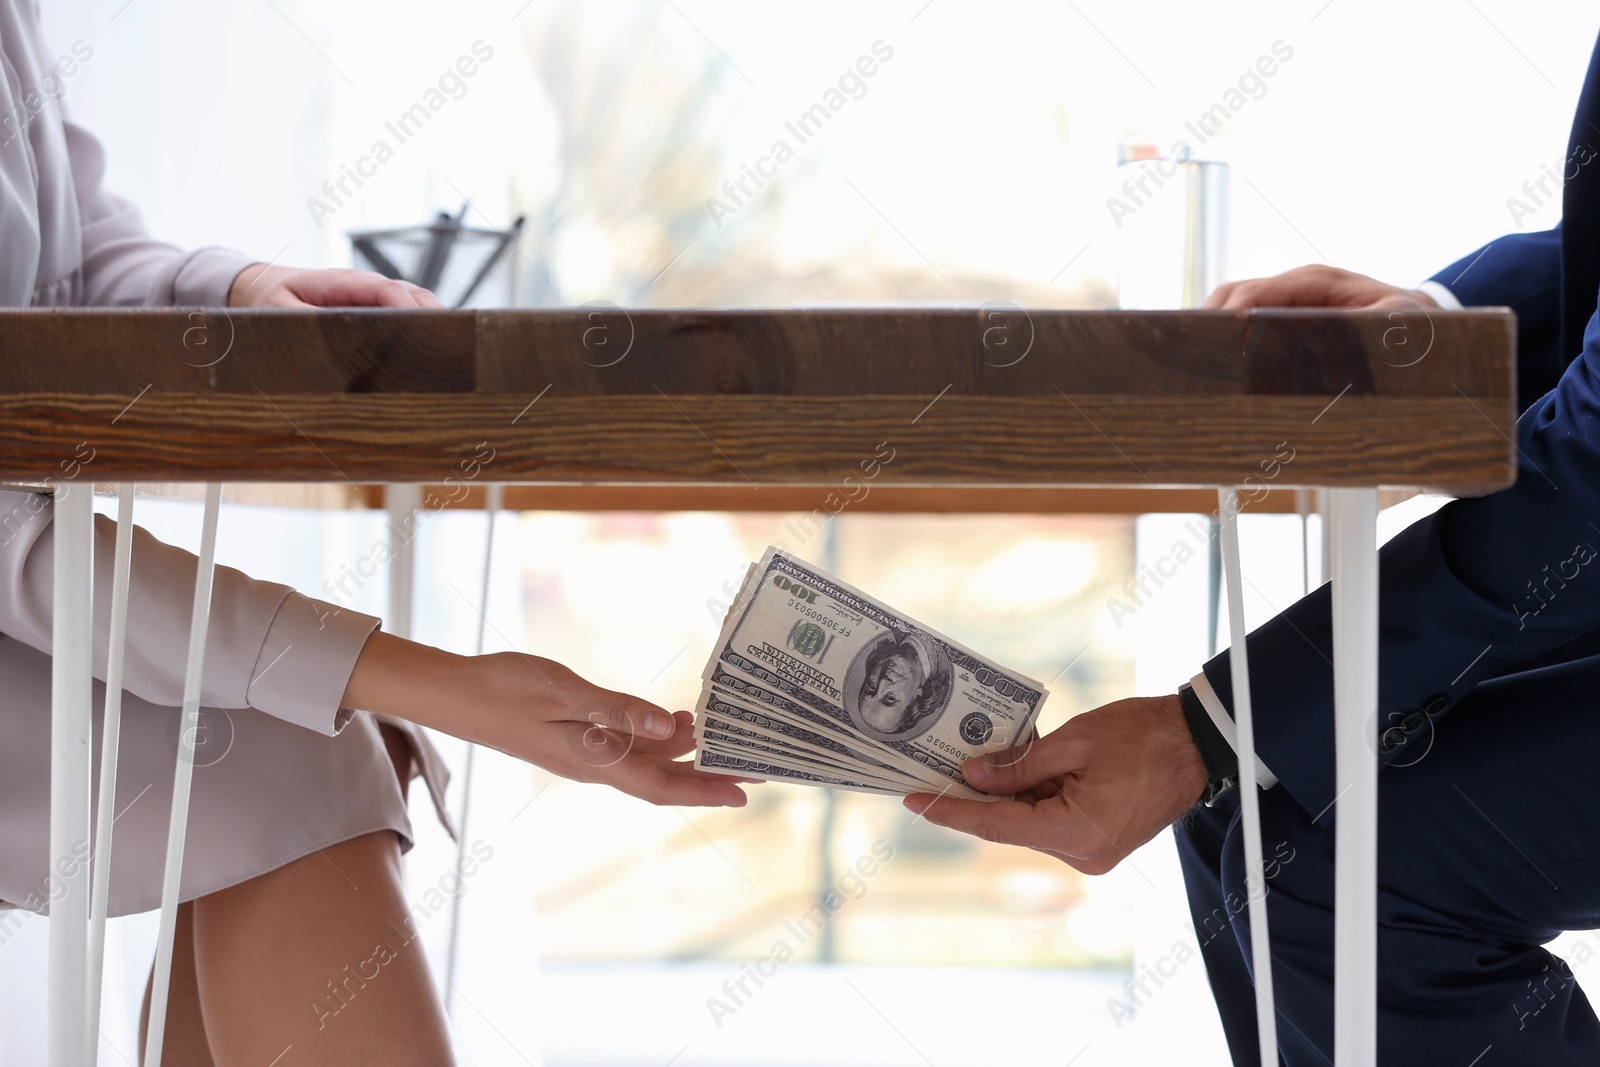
(85, 482), (133, 1067)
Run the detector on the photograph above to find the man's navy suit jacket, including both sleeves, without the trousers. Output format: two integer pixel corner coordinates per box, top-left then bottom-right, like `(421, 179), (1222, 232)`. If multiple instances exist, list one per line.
(1205, 31), (1600, 819)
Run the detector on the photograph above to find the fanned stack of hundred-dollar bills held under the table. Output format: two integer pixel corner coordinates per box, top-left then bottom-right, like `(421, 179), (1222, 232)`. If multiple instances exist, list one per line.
(694, 549), (1048, 800)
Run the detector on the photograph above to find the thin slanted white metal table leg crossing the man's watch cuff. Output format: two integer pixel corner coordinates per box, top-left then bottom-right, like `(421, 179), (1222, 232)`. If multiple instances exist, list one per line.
(1218, 490), (1278, 1064)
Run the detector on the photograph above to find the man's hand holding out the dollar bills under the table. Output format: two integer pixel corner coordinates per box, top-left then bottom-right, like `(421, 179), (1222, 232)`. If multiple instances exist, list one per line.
(906, 696), (1206, 875)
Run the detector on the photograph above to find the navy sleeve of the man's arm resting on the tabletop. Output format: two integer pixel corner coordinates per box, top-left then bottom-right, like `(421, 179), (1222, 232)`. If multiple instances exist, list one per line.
(1429, 222), (1576, 411)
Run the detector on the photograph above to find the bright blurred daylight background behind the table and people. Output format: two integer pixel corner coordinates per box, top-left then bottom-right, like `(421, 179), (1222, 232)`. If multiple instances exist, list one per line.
(0, 0), (1600, 1067)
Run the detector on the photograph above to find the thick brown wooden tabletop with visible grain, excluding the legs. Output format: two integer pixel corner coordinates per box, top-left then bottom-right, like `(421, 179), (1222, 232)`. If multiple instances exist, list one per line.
(0, 307), (1515, 493)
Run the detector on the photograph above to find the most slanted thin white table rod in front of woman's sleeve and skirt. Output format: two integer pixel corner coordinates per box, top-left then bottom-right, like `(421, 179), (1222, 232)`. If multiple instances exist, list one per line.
(144, 485), (222, 1067)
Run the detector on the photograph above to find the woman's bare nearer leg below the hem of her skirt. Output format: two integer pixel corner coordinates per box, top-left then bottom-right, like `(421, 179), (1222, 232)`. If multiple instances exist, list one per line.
(194, 830), (454, 1067)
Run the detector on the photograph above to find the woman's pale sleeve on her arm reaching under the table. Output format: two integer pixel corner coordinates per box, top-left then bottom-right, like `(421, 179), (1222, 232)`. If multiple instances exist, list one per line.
(0, 491), (378, 734)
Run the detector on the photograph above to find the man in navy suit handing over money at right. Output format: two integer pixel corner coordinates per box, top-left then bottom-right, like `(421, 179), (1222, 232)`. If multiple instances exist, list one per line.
(906, 29), (1600, 1067)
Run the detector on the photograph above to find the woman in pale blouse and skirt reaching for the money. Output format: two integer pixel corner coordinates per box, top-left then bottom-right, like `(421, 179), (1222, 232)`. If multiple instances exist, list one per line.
(0, 0), (744, 1067)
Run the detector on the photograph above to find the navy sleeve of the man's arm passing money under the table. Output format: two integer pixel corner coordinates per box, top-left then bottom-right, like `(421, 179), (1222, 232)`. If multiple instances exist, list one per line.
(1205, 303), (1600, 816)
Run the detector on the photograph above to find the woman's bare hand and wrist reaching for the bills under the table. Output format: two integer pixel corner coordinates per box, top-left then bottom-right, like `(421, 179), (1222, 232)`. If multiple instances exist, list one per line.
(344, 632), (746, 806)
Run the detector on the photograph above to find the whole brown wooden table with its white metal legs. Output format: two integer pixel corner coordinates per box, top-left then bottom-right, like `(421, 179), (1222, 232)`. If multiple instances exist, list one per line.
(0, 307), (1515, 1067)
